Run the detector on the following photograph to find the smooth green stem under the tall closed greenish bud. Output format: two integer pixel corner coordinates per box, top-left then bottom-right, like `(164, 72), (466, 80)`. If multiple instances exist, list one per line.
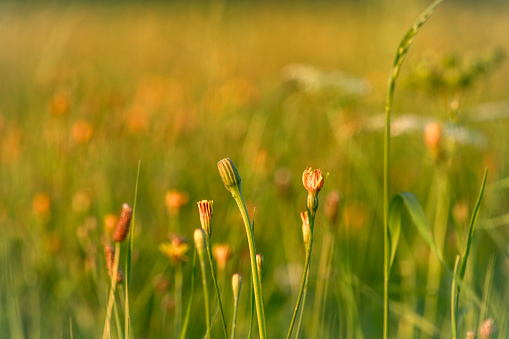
(231, 187), (267, 339)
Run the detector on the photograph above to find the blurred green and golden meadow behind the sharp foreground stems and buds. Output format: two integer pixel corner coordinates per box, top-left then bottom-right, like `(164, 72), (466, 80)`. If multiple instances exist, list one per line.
(0, 0), (509, 339)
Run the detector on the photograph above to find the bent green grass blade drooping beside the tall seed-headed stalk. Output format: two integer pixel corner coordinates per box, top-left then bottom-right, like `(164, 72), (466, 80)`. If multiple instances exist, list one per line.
(389, 192), (445, 270)
